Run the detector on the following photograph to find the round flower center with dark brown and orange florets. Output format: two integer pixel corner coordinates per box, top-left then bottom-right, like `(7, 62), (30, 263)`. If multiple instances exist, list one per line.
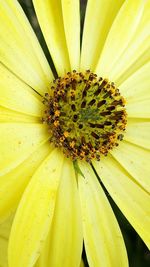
(43, 70), (126, 162)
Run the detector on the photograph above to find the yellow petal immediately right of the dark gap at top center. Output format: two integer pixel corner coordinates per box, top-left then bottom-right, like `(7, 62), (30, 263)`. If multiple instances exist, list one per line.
(81, 0), (124, 70)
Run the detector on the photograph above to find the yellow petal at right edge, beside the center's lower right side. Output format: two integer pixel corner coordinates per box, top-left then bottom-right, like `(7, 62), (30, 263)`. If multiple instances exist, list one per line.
(124, 119), (150, 149)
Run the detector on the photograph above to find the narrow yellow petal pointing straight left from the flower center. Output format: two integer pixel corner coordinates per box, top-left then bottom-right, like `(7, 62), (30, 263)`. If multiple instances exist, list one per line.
(0, 106), (40, 123)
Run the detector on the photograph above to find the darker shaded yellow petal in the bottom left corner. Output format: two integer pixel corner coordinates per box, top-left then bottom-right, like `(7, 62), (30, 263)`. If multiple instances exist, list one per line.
(0, 216), (13, 267)
